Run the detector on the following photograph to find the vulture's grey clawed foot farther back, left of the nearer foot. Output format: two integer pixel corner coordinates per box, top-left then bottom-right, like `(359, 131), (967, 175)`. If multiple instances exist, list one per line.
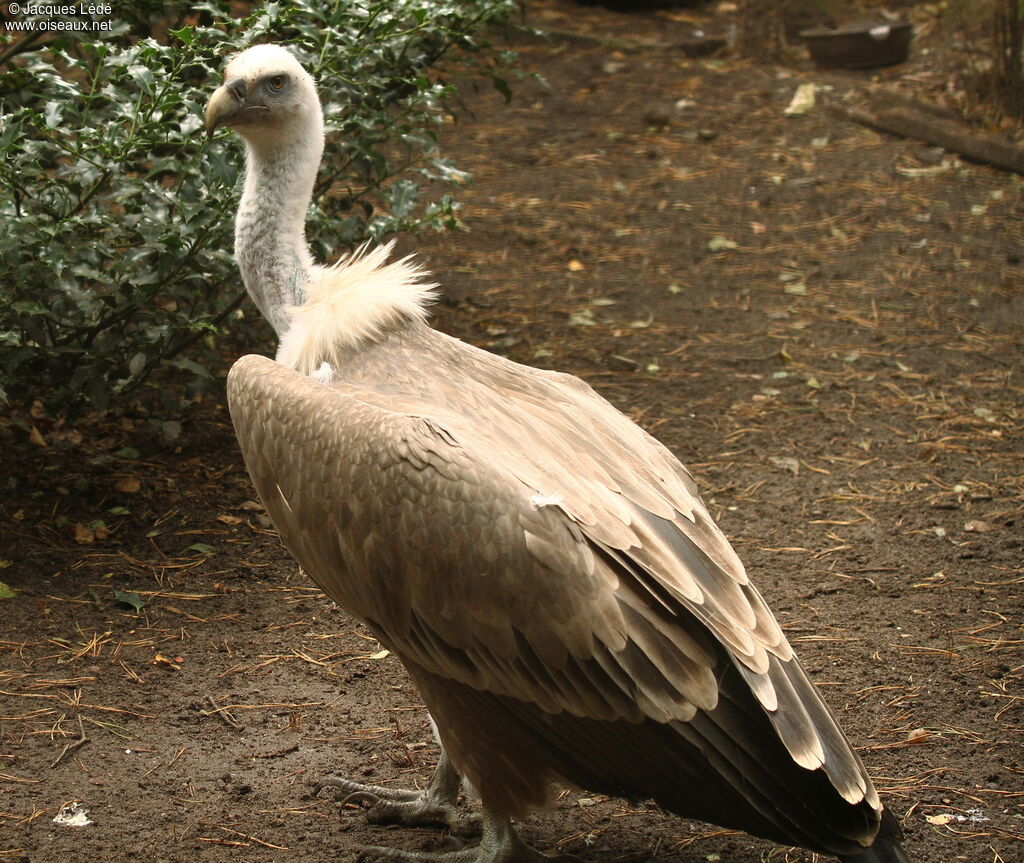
(317, 749), (479, 834)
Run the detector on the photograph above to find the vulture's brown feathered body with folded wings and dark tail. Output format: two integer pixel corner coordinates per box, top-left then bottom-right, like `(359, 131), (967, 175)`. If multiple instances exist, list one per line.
(228, 343), (881, 856)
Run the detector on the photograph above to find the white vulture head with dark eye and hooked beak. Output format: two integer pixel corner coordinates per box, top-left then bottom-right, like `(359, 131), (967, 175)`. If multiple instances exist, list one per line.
(206, 45), (324, 149)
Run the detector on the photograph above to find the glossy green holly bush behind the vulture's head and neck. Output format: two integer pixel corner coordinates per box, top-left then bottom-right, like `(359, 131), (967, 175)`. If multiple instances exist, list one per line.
(0, 0), (513, 414)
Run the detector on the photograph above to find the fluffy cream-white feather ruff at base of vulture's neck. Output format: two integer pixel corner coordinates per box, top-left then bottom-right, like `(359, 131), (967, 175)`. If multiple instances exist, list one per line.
(278, 241), (437, 375)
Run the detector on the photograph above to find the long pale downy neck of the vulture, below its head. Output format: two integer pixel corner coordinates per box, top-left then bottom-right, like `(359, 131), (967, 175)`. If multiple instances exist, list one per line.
(234, 130), (324, 338)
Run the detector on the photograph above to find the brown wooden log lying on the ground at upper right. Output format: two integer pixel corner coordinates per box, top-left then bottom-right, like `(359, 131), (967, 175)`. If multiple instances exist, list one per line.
(846, 105), (1024, 174)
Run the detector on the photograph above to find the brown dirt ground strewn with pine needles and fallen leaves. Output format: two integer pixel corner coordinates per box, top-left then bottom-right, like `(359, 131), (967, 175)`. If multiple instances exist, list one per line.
(0, 0), (1024, 863)
